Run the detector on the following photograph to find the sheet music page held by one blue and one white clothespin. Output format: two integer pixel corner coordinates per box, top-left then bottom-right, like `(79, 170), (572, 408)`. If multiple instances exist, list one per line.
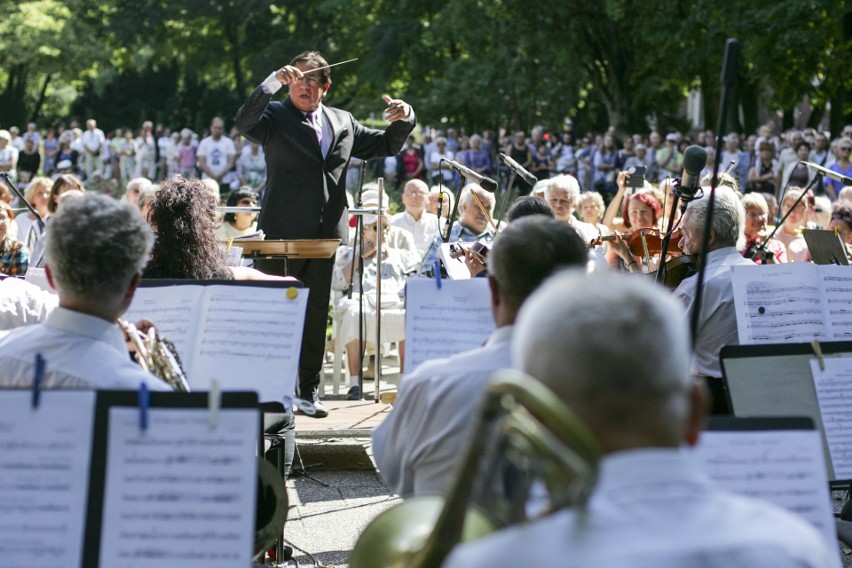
(99, 407), (258, 568)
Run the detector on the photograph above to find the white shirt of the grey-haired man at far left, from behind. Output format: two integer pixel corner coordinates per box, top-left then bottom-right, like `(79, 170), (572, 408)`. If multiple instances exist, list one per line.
(0, 307), (171, 391)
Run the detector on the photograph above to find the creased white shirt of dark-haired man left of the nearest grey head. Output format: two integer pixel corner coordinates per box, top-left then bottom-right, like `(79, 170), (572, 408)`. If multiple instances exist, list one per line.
(373, 326), (512, 497)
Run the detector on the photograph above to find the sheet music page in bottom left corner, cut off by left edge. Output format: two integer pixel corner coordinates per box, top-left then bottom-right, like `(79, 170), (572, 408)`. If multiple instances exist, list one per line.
(0, 390), (95, 568)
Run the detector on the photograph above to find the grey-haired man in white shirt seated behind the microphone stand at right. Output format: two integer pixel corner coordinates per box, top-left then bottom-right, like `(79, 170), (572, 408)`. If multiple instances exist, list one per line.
(674, 186), (754, 414)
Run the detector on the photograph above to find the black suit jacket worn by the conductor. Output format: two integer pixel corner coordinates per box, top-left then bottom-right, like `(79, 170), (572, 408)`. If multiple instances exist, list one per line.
(236, 87), (415, 243)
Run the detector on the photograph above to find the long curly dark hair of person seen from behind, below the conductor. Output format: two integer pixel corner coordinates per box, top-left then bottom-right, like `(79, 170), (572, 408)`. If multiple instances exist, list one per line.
(142, 178), (234, 280)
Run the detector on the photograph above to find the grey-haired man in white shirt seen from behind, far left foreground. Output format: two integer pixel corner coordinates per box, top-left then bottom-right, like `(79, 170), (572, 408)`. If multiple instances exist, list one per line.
(0, 193), (170, 390)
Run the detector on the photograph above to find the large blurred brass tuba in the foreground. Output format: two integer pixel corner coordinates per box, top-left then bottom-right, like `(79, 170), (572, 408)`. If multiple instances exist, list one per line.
(349, 370), (600, 568)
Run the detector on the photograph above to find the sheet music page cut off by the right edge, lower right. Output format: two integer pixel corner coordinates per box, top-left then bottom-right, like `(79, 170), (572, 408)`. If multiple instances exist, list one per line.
(811, 357), (852, 479)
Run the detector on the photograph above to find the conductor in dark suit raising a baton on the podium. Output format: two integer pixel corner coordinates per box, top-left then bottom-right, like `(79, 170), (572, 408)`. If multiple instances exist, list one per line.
(236, 51), (415, 418)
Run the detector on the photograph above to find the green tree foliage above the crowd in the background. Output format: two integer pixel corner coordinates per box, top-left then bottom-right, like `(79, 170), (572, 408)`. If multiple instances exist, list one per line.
(0, 0), (852, 136)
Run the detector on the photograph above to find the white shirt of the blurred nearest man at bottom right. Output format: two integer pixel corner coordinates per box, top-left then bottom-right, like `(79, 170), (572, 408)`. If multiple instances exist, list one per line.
(444, 449), (840, 568)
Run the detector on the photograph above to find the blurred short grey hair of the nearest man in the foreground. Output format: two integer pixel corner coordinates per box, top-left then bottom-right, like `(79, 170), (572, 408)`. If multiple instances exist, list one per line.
(510, 272), (691, 444)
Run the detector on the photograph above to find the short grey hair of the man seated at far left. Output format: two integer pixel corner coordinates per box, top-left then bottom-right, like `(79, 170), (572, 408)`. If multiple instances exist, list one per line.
(45, 193), (154, 302)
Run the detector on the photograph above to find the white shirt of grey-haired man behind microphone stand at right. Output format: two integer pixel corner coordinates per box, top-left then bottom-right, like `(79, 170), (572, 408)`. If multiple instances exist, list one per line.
(674, 247), (754, 378)
